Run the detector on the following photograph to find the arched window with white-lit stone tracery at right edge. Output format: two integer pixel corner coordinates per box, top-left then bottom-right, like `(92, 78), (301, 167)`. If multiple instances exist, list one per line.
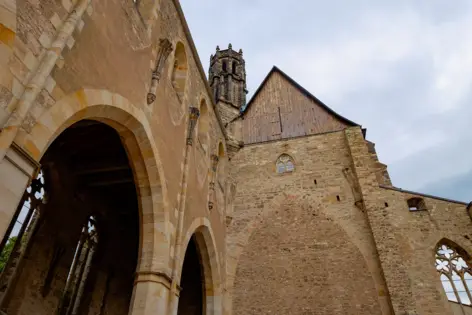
(436, 243), (472, 305)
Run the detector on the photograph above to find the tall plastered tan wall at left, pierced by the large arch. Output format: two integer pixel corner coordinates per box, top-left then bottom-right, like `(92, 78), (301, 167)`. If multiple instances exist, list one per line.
(0, 0), (227, 312)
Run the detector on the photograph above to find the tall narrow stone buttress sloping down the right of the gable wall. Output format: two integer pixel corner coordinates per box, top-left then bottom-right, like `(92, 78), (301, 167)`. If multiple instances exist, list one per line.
(345, 127), (417, 315)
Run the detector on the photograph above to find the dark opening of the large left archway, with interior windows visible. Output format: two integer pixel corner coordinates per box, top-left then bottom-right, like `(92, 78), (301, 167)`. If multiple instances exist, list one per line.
(0, 119), (142, 315)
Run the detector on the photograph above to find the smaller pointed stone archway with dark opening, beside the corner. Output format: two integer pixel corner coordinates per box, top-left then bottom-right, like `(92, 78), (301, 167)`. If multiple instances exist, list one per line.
(177, 218), (222, 315)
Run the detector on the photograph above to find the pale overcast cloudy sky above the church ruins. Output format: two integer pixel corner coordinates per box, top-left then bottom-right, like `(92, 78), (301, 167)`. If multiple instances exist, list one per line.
(181, 0), (472, 202)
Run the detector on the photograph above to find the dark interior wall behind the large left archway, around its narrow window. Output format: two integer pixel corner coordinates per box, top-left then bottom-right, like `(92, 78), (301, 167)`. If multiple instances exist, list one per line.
(3, 161), (139, 315)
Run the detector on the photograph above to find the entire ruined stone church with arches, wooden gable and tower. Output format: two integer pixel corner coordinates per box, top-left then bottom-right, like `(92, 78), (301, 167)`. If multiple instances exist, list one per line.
(0, 0), (472, 315)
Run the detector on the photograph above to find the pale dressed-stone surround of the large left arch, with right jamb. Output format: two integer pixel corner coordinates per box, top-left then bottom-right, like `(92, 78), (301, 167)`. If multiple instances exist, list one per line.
(8, 89), (170, 314)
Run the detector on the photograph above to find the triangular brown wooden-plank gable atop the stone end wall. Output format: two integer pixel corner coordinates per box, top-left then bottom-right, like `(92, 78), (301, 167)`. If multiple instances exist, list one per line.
(243, 67), (357, 143)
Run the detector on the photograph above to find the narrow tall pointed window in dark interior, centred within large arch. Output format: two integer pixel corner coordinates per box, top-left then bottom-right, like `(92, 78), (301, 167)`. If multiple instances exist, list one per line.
(60, 216), (98, 315)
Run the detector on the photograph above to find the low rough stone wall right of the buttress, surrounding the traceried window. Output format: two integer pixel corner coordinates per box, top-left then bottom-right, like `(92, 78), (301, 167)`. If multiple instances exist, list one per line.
(372, 188), (472, 314)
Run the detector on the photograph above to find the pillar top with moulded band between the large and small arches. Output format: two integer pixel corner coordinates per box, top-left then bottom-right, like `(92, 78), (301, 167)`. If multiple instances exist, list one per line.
(128, 272), (171, 315)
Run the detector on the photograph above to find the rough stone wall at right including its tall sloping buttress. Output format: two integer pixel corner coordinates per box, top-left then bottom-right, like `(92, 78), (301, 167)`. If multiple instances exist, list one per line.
(345, 127), (472, 314)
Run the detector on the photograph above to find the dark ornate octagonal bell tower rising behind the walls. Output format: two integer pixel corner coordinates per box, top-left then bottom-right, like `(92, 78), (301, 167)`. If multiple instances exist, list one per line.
(208, 44), (247, 125)
